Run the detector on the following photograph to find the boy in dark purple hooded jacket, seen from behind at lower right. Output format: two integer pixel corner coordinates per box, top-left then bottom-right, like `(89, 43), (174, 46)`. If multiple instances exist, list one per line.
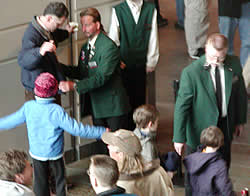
(184, 126), (235, 196)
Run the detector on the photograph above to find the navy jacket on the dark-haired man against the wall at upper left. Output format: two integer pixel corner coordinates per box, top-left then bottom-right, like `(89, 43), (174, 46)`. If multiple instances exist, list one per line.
(18, 17), (69, 91)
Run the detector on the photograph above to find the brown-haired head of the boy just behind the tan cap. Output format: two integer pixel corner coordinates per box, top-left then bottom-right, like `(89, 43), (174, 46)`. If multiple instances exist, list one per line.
(133, 104), (159, 131)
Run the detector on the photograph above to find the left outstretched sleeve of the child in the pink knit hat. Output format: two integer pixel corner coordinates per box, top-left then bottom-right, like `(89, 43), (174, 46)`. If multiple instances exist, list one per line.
(0, 106), (26, 131)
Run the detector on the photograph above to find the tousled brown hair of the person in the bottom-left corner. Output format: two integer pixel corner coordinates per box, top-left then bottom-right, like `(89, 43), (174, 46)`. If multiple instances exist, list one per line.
(0, 150), (28, 182)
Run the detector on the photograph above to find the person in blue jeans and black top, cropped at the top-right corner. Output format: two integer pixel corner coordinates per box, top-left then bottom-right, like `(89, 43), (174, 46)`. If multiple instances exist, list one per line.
(218, 0), (250, 66)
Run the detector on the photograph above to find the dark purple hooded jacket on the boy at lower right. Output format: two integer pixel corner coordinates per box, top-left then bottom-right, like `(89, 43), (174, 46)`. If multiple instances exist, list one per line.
(184, 147), (235, 196)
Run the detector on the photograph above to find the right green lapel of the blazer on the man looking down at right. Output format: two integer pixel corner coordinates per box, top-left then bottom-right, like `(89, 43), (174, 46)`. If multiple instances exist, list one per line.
(224, 64), (233, 106)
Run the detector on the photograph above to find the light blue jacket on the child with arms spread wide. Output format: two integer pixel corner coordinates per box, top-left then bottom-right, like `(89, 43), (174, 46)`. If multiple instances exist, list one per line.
(0, 97), (106, 161)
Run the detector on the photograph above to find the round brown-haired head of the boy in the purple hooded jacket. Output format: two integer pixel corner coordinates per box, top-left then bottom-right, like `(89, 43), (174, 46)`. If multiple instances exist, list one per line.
(200, 126), (224, 148)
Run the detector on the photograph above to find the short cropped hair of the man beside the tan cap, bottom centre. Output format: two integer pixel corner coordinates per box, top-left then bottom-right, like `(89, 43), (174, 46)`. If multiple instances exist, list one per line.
(90, 155), (119, 186)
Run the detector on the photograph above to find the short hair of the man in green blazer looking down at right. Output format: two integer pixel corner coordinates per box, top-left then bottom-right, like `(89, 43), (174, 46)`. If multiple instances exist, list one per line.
(206, 33), (228, 51)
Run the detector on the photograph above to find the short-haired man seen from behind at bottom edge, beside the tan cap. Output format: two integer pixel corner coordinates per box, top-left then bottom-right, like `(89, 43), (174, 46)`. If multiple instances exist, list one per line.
(87, 155), (136, 196)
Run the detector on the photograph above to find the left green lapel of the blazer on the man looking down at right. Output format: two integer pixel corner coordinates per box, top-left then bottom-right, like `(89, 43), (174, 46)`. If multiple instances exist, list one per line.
(201, 66), (217, 105)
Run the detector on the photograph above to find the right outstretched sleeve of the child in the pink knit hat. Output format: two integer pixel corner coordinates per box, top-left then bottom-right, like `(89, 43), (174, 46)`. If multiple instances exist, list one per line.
(52, 108), (106, 139)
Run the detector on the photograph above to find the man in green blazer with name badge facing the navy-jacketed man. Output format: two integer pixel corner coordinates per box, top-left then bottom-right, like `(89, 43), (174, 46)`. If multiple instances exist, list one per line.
(59, 8), (130, 131)
